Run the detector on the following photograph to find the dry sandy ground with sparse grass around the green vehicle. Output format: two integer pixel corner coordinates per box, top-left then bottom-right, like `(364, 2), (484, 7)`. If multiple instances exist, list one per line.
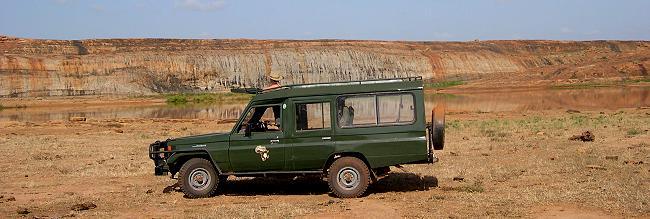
(0, 105), (650, 218)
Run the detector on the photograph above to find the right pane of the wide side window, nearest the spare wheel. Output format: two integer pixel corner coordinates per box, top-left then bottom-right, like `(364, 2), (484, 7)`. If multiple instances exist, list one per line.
(377, 94), (415, 124)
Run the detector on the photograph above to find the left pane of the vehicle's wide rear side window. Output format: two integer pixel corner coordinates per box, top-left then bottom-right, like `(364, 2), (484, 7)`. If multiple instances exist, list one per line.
(337, 95), (377, 127)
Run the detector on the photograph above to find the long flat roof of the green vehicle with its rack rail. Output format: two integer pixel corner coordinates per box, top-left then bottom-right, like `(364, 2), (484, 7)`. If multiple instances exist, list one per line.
(253, 77), (424, 101)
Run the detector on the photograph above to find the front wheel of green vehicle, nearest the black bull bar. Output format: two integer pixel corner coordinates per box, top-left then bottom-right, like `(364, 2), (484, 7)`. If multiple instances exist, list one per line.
(178, 158), (222, 198)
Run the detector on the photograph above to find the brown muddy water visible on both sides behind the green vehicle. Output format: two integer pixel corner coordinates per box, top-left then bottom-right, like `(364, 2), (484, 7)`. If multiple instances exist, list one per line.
(0, 87), (650, 122)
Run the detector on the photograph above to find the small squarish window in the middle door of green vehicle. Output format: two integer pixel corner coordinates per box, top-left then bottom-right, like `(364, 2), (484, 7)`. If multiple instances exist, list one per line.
(296, 103), (332, 131)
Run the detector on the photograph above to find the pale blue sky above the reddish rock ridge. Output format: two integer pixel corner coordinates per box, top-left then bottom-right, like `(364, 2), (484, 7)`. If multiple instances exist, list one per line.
(0, 0), (650, 41)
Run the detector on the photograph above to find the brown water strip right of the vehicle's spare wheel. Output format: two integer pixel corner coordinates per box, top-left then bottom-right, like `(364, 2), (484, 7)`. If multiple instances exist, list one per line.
(425, 87), (650, 112)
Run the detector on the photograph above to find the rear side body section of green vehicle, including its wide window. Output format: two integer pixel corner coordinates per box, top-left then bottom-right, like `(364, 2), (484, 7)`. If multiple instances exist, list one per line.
(334, 91), (428, 168)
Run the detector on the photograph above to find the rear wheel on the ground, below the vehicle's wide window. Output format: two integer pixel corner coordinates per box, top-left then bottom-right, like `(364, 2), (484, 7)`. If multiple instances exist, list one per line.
(327, 157), (370, 198)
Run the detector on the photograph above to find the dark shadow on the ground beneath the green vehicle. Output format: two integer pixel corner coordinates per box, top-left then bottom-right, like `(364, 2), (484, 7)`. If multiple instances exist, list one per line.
(166, 172), (438, 196)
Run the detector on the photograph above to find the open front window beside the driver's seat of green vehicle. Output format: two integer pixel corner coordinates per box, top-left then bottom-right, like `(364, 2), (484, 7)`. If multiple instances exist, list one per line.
(237, 105), (282, 134)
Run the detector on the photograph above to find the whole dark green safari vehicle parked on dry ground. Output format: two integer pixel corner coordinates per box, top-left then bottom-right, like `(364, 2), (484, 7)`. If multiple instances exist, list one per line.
(149, 77), (444, 198)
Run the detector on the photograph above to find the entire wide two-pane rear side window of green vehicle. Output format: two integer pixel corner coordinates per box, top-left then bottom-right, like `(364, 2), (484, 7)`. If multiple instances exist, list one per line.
(336, 93), (415, 128)
